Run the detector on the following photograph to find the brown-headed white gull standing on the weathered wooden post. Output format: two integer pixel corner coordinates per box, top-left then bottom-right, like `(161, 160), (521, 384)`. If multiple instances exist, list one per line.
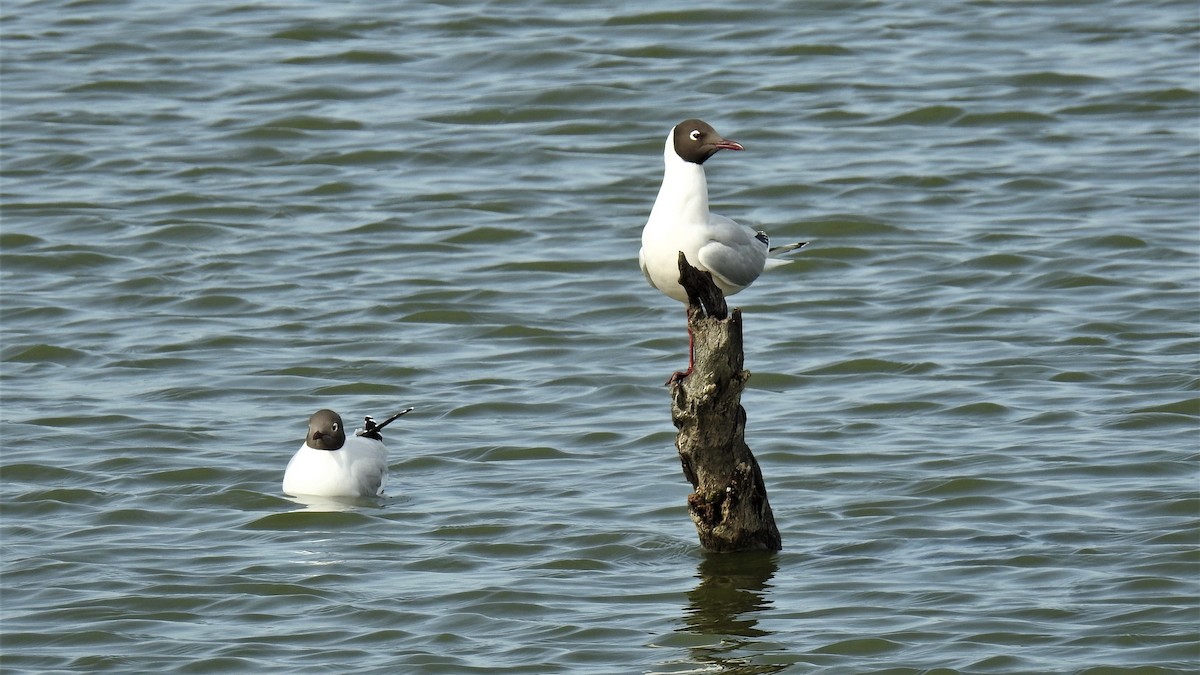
(638, 119), (808, 380)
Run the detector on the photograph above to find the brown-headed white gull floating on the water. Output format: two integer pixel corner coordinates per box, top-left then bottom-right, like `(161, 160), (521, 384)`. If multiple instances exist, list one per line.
(283, 408), (413, 497)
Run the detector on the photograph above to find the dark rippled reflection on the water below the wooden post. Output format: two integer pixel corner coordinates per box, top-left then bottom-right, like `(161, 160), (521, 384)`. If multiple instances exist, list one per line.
(678, 552), (790, 675)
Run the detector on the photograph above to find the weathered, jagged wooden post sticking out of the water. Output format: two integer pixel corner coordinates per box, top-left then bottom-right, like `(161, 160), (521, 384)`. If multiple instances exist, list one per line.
(671, 252), (782, 552)
